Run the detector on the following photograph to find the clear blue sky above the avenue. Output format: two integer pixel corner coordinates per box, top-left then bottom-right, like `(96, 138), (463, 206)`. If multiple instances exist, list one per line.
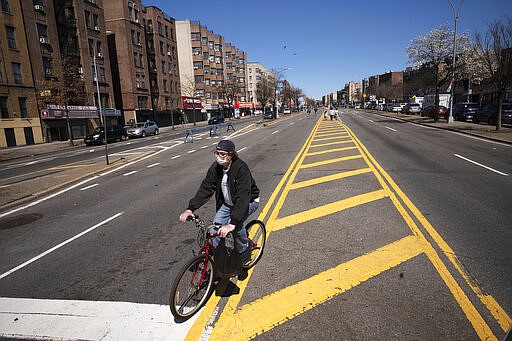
(147, 0), (512, 98)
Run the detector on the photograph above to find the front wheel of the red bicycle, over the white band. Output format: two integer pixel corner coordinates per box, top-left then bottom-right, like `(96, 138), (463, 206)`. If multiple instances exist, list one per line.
(169, 254), (214, 319)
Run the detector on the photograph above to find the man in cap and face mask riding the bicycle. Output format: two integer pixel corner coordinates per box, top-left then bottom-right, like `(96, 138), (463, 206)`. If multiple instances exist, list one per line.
(180, 140), (260, 270)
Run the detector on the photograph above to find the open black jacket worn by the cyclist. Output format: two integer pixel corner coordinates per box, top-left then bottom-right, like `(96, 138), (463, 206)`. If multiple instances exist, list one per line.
(188, 155), (260, 229)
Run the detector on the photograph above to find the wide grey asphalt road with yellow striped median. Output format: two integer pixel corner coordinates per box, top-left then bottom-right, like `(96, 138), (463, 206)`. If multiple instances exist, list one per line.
(0, 110), (512, 340)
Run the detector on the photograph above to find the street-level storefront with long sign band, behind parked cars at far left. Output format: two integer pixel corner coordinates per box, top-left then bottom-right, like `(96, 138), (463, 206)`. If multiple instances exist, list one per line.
(40, 105), (121, 142)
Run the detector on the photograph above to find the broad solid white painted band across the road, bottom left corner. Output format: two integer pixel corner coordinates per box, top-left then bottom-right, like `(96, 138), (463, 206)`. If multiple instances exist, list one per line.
(0, 297), (200, 341)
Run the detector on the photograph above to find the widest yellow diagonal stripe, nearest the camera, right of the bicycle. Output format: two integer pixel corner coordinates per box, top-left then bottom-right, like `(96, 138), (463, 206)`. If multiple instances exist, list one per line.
(210, 236), (423, 340)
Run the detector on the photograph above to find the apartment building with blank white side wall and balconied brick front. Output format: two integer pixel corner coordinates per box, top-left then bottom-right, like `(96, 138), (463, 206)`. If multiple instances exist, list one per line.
(176, 20), (247, 119)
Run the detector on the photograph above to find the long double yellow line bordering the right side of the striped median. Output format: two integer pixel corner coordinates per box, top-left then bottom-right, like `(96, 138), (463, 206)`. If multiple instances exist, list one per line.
(345, 123), (500, 340)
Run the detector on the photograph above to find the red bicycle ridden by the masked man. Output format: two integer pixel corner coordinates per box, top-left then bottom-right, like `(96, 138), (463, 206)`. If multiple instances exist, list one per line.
(169, 215), (267, 320)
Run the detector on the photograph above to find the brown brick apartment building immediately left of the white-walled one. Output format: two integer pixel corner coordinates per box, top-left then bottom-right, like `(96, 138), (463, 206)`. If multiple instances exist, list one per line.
(105, 0), (181, 123)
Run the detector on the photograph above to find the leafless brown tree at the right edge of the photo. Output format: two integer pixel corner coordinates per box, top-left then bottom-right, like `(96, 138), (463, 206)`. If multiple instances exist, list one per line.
(474, 17), (512, 130)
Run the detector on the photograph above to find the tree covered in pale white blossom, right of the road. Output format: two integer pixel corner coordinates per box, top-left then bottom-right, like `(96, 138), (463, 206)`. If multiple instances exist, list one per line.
(406, 25), (470, 122)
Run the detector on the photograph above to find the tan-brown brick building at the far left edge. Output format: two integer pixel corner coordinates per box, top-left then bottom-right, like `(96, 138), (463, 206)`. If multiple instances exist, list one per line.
(0, 0), (43, 147)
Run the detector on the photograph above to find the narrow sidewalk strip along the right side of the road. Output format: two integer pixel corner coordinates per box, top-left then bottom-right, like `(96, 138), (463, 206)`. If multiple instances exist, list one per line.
(365, 110), (512, 144)
